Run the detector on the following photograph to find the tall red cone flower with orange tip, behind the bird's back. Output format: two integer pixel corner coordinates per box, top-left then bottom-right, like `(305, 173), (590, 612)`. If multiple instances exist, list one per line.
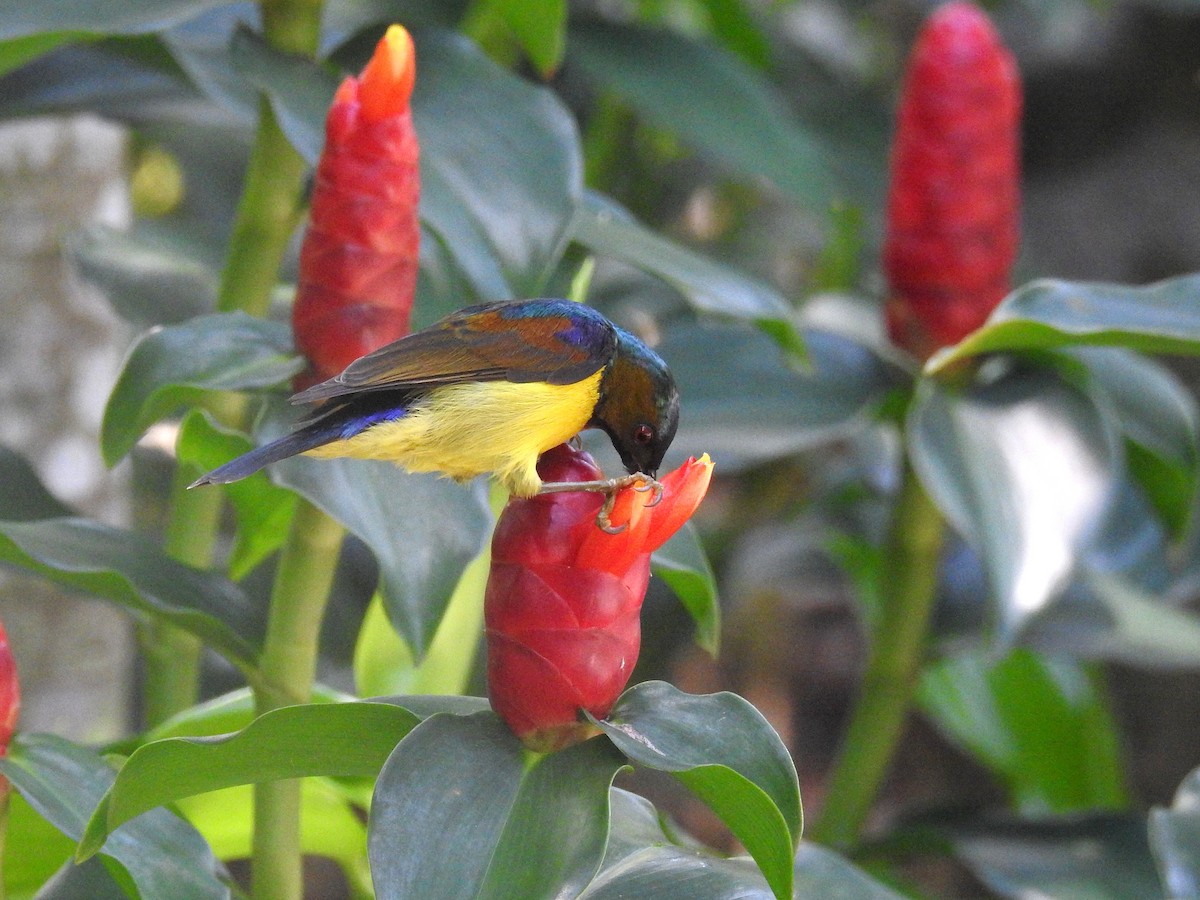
(292, 25), (420, 390)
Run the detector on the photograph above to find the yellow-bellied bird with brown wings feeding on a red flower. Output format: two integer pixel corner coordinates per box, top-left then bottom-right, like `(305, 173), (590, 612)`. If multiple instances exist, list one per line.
(190, 299), (679, 530)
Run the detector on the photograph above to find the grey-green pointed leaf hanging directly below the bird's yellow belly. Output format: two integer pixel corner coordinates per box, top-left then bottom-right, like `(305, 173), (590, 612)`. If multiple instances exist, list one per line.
(271, 441), (492, 658)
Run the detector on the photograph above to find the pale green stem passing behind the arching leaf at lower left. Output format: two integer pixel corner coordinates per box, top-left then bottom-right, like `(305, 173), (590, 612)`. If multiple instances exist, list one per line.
(251, 500), (343, 900)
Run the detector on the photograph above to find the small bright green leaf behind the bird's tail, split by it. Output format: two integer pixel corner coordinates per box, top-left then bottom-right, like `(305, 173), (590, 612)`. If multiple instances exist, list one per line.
(175, 409), (298, 580)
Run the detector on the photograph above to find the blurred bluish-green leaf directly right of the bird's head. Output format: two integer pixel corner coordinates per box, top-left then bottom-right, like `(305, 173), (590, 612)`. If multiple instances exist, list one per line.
(658, 324), (901, 472)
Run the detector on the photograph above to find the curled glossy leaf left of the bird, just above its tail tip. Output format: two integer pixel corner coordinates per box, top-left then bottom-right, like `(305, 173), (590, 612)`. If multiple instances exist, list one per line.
(101, 312), (304, 466)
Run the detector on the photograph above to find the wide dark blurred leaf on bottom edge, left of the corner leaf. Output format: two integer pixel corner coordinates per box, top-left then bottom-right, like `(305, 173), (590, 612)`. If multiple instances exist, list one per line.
(950, 816), (1163, 900)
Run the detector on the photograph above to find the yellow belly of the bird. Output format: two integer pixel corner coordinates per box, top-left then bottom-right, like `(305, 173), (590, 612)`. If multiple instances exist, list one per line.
(307, 371), (602, 497)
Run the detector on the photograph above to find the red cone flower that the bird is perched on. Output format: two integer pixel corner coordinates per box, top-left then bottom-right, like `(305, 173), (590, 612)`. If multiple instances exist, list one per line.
(484, 444), (713, 751)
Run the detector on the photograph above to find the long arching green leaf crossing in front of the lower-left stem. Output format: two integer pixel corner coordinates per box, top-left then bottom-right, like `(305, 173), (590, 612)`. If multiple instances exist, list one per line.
(79, 702), (418, 858)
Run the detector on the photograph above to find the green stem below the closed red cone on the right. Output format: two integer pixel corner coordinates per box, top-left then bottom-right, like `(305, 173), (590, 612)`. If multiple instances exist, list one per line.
(810, 464), (944, 847)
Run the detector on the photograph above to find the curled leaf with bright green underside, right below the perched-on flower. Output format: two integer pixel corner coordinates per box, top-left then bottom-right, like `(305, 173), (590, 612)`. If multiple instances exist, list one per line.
(596, 682), (803, 898)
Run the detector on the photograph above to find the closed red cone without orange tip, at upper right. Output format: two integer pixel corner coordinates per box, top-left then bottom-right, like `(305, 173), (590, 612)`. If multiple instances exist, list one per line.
(883, 2), (1021, 359)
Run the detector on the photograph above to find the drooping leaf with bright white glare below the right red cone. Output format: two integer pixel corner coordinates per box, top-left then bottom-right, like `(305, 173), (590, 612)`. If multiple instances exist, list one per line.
(907, 365), (1122, 641)
